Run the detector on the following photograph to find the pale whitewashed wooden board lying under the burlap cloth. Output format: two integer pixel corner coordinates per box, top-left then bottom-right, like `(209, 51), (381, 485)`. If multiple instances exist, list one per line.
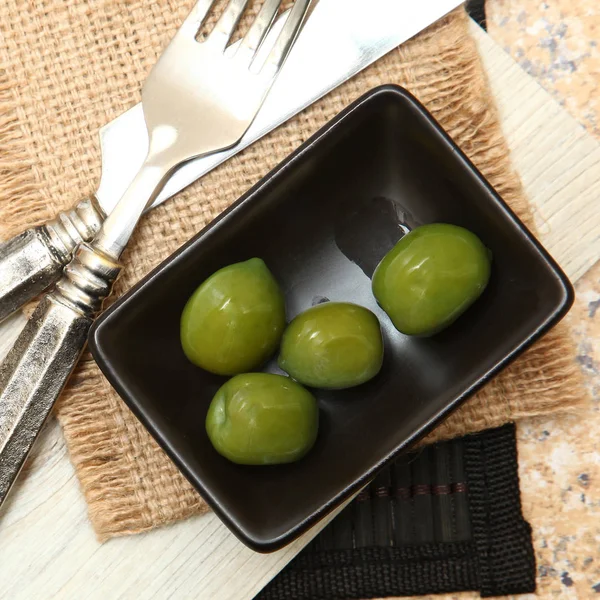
(0, 24), (600, 600)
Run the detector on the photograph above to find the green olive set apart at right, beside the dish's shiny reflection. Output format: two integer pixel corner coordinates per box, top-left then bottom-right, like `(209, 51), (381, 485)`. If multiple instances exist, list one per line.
(373, 223), (491, 336)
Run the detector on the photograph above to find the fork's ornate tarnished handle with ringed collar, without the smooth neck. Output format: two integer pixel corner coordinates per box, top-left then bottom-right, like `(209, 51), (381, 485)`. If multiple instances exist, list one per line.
(0, 243), (121, 506)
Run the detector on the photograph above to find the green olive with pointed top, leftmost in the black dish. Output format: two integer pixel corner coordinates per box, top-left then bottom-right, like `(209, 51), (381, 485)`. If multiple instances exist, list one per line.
(180, 258), (285, 375)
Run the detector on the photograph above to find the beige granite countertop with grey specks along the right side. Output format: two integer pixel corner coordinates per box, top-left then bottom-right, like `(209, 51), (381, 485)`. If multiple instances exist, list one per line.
(418, 0), (600, 600)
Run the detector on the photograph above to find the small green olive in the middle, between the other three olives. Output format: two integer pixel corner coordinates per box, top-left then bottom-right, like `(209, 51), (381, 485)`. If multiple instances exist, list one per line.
(279, 302), (383, 389)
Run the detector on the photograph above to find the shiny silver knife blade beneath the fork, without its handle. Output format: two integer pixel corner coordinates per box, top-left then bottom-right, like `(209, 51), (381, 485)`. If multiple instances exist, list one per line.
(101, 0), (461, 214)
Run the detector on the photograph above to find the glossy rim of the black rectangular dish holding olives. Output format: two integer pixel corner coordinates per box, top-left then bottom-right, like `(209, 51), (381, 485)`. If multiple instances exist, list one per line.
(88, 84), (574, 552)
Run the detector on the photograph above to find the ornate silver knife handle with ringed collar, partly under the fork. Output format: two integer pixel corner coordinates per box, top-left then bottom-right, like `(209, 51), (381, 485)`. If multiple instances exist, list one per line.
(0, 198), (104, 321)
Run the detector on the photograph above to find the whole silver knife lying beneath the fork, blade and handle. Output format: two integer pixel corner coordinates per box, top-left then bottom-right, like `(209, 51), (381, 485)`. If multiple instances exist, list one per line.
(0, 0), (462, 320)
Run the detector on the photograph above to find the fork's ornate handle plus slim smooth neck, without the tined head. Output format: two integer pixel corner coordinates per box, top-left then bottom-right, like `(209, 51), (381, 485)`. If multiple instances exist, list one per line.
(0, 152), (172, 506)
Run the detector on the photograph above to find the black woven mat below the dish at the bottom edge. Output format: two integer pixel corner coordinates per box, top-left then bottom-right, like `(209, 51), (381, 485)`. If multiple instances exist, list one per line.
(256, 425), (536, 600)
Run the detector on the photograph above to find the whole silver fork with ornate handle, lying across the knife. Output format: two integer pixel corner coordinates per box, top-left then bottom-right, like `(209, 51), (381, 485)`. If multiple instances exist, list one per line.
(0, 0), (310, 506)
